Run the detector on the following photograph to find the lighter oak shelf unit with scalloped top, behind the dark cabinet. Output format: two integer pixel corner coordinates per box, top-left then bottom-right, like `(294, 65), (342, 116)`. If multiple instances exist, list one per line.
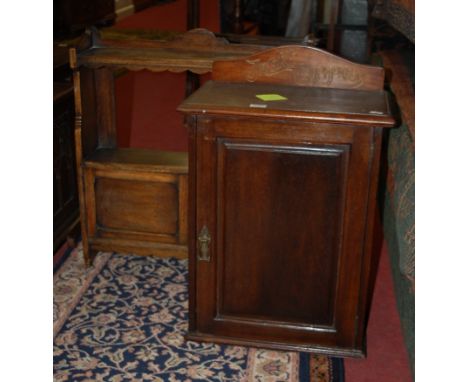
(70, 29), (266, 264)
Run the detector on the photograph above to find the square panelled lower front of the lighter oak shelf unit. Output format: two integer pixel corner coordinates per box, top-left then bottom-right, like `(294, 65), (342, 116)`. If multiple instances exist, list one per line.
(84, 165), (187, 257)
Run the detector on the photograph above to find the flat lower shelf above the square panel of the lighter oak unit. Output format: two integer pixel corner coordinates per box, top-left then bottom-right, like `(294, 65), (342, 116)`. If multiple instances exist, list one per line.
(84, 148), (188, 174)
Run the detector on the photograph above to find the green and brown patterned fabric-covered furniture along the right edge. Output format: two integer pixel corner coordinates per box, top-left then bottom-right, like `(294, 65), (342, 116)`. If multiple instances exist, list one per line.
(379, 50), (416, 377)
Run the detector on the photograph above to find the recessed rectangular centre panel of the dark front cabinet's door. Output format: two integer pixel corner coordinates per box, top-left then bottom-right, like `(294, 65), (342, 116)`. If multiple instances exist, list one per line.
(218, 140), (348, 328)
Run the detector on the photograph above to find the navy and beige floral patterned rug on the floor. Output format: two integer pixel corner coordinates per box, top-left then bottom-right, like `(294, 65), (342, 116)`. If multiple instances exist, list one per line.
(54, 248), (344, 382)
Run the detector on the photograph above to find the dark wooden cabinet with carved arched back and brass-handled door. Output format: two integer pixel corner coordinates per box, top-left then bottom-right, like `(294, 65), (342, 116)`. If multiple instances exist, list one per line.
(179, 46), (394, 357)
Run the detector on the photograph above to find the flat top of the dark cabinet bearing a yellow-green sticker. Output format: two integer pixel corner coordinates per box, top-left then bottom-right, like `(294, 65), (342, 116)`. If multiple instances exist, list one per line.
(178, 81), (394, 127)
